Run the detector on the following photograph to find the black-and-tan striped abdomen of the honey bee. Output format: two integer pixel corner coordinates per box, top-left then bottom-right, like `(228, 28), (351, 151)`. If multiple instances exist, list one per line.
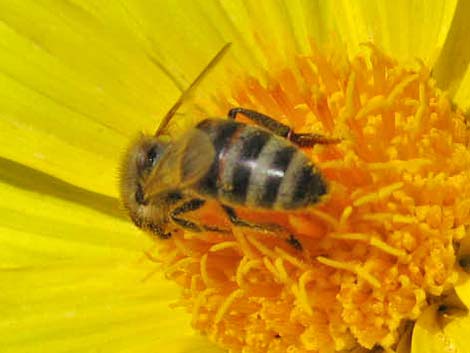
(196, 119), (327, 210)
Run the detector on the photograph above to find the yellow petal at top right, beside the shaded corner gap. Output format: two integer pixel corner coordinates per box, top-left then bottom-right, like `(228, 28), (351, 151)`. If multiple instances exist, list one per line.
(314, 0), (456, 64)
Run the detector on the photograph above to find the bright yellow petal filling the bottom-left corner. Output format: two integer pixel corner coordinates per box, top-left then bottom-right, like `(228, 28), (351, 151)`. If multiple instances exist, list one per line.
(0, 261), (219, 353)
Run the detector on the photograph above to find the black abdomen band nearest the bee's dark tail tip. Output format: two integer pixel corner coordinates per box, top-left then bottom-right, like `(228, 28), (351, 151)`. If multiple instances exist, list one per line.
(259, 146), (296, 208)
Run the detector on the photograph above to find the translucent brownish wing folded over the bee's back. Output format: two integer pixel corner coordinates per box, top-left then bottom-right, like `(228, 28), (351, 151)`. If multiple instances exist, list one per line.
(144, 129), (215, 196)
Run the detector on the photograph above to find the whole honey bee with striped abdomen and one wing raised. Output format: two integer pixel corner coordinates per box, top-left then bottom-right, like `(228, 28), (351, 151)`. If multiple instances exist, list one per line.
(121, 45), (337, 249)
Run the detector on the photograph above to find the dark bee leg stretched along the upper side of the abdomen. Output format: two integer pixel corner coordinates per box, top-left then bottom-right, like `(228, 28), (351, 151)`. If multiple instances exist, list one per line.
(227, 107), (341, 147)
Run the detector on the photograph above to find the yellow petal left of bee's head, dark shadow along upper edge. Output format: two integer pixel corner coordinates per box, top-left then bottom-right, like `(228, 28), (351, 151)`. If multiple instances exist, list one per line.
(0, 160), (152, 268)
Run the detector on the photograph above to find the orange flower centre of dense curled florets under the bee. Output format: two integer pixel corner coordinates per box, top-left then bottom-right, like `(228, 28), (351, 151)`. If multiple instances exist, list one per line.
(155, 46), (470, 353)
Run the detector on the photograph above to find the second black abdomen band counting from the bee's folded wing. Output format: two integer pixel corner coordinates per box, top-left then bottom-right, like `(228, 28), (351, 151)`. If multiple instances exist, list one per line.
(229, 127), (271, 205)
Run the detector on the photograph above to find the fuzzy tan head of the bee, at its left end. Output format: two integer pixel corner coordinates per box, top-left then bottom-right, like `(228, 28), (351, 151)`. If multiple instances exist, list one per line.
(120, 135), (167, 227)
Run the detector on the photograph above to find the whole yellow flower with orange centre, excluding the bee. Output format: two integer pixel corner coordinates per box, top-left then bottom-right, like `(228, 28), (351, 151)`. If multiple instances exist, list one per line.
(0, 0), (470, 353)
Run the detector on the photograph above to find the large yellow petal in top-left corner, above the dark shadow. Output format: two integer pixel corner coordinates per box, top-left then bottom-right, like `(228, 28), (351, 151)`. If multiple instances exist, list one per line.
(0, 1), (180, 195)
